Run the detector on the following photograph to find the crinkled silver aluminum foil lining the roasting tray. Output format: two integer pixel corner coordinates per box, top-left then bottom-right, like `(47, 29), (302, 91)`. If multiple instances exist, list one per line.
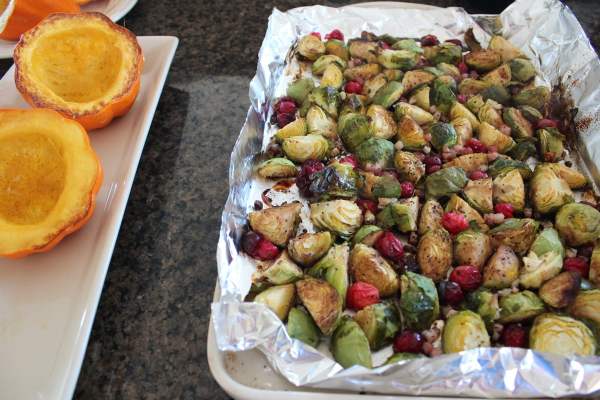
(212, 0), (600, 398)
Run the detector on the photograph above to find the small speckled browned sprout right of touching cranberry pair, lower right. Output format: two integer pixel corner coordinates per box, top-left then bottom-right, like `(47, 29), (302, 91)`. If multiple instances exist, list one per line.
(483, 245), (521, 289)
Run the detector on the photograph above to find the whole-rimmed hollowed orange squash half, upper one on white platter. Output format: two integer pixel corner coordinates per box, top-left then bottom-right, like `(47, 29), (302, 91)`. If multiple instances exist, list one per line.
(13, 13), (144, 130)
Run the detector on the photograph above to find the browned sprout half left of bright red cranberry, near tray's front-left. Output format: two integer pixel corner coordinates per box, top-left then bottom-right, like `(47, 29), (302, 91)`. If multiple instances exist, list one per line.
(296, 278), (343, 335)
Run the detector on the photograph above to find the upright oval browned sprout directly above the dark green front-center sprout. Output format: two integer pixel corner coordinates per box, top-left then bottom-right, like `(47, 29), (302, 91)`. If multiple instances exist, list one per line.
(417, 228), (453, 282)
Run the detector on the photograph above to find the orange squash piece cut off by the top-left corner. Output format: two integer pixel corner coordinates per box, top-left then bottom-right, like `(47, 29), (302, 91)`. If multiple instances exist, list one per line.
(0, 0), (80, 40)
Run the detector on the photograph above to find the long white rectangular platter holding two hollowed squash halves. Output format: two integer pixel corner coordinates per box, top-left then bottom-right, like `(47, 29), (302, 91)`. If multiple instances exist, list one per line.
(0, 36), (178, 400)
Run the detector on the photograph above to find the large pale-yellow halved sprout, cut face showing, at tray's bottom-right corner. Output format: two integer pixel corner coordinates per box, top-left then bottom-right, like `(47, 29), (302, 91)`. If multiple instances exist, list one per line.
(529, 313), (597, 357)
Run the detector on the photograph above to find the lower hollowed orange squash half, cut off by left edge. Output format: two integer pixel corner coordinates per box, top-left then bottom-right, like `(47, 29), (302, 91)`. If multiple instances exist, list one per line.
(0, 109), (102, 258)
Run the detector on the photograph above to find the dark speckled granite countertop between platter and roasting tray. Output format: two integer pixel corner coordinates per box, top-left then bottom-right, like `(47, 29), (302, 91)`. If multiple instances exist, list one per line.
(0, 0), (600, 400)
